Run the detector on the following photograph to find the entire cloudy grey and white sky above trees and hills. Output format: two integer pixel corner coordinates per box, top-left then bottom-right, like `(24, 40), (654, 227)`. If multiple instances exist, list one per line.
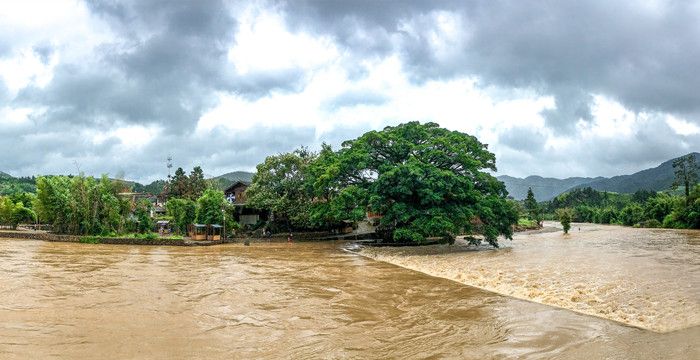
(0, 0), (700, 182)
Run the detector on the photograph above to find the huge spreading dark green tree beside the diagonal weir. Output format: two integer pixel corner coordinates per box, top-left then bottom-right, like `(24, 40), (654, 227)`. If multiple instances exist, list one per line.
(316, 122), (517, 246)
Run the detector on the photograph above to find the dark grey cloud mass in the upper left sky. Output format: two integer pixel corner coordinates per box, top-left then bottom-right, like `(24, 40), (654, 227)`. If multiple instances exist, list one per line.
(16, 1), (236, 132)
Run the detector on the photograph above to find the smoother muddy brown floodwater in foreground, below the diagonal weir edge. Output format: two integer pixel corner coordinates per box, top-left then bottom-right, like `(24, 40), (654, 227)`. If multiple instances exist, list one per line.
(0, 228), (700, 359)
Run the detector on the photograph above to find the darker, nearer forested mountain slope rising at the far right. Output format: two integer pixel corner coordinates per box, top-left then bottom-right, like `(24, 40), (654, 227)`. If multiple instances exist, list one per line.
(576, 152), (700, 193)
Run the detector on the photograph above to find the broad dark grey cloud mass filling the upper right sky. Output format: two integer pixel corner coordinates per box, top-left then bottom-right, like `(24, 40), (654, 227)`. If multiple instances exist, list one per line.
(286, 0), (700, 132)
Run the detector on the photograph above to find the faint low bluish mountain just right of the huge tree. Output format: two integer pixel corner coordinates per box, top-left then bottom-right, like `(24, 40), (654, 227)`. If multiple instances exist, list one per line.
(498, 175), (602, 201)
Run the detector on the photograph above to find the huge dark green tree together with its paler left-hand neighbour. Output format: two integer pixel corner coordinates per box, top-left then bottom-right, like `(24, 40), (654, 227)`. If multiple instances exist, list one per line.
(246, 122), (518, 246)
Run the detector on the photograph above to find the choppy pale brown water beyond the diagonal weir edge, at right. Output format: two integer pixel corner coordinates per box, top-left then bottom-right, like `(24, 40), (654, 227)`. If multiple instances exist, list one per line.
(360, 223), (700, 332)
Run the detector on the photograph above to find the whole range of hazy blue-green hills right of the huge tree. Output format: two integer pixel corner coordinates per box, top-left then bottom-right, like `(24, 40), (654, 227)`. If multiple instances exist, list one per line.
(498, 152), (700, 201)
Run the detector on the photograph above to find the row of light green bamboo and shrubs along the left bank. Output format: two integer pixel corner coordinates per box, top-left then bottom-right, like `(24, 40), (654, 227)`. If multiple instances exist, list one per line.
(28, 171), (235, 236)
